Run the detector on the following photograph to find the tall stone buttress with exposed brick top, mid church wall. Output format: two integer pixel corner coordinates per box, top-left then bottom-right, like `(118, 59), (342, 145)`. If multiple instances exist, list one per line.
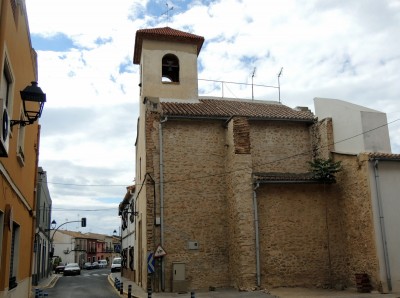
(225, 117), (256, 290)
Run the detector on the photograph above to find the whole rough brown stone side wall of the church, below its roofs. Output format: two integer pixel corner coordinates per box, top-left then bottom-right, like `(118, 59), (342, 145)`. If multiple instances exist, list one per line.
(143, 114), (377, 291)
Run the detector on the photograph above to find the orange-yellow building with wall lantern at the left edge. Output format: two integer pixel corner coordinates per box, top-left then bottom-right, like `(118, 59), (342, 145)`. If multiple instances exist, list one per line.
(0, 0), (45, 298)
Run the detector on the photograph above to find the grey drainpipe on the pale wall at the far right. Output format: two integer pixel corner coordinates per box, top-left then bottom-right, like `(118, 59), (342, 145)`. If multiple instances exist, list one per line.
(374, 160), (392, 292)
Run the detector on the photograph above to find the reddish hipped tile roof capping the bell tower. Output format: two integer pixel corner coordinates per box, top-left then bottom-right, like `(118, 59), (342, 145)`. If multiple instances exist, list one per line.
(133, 27), (204, 64)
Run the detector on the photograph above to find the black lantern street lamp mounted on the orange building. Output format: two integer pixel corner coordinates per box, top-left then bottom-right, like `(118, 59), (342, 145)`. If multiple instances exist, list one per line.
(10, 81), (46, 127)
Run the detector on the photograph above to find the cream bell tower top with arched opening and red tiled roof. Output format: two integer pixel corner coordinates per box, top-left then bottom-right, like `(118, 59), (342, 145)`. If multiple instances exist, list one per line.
(133, 27), (204, 100)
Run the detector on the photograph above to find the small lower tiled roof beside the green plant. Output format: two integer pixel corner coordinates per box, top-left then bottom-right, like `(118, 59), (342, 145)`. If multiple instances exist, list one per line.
(253, 173), (321, 183)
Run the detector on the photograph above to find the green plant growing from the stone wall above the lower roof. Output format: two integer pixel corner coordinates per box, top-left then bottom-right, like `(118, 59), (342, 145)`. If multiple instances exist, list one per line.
(308, 158), (342, 183)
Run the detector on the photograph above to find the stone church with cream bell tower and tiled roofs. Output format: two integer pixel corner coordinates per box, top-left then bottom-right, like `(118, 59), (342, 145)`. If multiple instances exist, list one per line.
(126, 27), (399, 292)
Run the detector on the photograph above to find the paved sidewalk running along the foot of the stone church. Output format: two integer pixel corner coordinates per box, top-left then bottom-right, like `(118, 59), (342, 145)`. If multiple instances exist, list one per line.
(108, 272), (400, 298)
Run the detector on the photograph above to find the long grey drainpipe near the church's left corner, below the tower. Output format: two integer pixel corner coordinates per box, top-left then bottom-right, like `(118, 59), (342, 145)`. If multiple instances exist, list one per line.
(158, 117), (168, 292)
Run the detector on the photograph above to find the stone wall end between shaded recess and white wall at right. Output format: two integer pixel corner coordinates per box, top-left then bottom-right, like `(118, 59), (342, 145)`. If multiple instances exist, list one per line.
(334, 154), (379, 289)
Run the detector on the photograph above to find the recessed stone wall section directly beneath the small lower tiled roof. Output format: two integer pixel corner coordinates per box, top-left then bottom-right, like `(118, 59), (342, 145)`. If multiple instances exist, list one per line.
(257, 184), (340, 288)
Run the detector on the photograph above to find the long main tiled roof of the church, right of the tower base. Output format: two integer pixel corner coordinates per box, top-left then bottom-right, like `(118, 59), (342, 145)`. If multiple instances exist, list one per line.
(161, 99), (315, 122)
